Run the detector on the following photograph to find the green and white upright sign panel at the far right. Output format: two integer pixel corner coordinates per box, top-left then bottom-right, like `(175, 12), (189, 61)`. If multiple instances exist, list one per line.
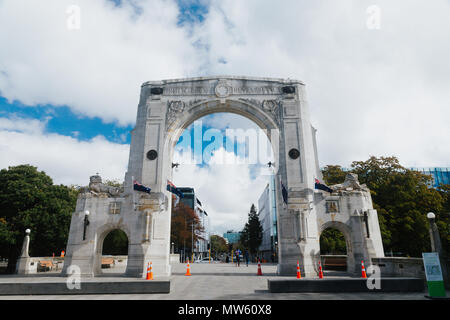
(422, 252), (446, 297)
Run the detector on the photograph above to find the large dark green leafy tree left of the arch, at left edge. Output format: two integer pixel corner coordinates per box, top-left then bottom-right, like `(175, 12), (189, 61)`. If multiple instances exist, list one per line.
(0, 165), (78, 273)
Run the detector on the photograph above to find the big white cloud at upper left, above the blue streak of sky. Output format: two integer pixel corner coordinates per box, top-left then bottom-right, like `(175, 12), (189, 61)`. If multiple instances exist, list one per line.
(0, 0), (197, 124)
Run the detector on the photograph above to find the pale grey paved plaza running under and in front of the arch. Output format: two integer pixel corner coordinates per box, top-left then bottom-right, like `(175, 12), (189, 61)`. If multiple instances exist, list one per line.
(0, 263), (440, 300)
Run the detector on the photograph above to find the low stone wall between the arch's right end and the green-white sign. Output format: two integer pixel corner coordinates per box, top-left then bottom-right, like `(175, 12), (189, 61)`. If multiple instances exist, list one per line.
(372, 257), (425, 279)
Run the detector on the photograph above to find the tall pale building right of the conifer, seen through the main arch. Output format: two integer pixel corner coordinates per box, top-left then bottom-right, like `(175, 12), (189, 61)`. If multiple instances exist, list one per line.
(258, 176), (278, 261)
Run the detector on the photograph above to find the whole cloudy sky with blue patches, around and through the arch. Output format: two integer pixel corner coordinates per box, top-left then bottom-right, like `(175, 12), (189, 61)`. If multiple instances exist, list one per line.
(0, 0), (450, 232)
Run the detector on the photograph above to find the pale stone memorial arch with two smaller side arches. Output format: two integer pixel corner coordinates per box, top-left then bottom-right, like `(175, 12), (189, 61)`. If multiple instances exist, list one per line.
(63, 77), (383, 277)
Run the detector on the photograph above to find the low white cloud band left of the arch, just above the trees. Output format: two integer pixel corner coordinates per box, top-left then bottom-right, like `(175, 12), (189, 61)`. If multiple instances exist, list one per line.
(0, 118), (129, 186)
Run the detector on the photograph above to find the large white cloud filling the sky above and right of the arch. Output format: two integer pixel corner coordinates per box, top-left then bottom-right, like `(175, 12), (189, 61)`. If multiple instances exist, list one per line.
(196, 0), (450, 166)
